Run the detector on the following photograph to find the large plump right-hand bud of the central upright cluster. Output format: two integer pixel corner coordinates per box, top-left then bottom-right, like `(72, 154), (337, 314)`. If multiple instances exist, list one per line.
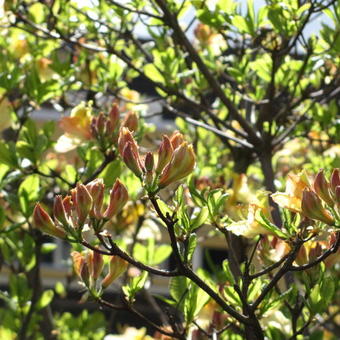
(158, 142), (195, 188)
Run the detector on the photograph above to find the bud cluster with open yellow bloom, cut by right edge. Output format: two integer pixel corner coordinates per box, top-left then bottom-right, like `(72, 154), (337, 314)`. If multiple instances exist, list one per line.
(272, 169), (340, 225)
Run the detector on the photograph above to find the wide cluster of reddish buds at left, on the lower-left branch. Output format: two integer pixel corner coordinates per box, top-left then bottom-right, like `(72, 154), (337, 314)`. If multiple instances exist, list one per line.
(33, 179), (128, 239)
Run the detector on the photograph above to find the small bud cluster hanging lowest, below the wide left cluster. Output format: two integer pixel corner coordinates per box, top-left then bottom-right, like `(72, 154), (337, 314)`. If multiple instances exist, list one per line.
(71, 250), (128, 290)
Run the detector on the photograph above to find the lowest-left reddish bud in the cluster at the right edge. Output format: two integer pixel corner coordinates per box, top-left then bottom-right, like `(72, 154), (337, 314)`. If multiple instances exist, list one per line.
(301, 189), (334, 225)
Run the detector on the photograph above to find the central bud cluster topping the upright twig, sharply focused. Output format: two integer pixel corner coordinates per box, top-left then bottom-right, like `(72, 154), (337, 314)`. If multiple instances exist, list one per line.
(118, 127), (195, 192)
